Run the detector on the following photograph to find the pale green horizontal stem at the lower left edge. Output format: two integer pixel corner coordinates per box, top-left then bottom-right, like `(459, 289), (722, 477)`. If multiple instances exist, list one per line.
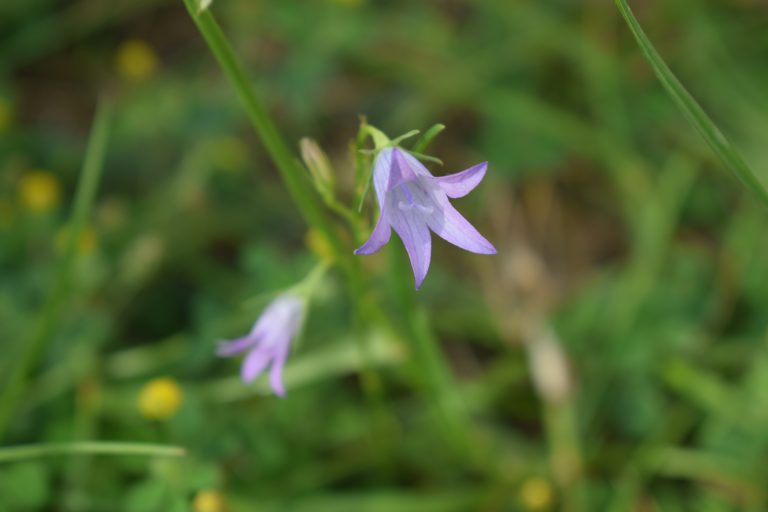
(0, 441), (187, 463)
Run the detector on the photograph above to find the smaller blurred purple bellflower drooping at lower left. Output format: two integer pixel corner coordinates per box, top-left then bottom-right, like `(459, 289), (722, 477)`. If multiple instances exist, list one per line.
(216, 295), (304, 396)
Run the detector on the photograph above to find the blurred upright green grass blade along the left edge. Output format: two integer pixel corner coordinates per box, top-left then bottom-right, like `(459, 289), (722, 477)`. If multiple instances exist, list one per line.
(0, 102), (111, 441)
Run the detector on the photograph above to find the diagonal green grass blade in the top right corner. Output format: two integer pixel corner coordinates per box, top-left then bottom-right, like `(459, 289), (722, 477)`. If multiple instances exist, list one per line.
(615, 0), (768, 208)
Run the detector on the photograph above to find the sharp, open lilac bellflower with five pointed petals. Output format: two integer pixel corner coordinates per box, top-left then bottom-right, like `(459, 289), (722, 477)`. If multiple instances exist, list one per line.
(355, 147), (496, 290)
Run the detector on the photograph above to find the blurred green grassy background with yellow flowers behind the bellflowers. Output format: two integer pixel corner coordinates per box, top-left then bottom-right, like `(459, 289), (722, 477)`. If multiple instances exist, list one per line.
(0, 0), (768, 512)
